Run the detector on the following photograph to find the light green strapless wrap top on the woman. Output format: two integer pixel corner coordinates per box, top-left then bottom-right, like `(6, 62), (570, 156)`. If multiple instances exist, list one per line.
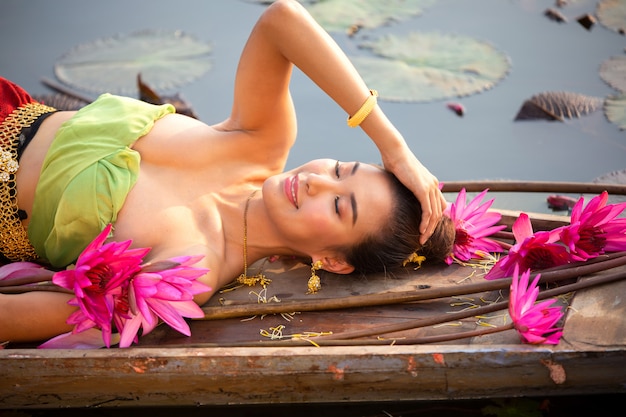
(28, 94), (175, 267)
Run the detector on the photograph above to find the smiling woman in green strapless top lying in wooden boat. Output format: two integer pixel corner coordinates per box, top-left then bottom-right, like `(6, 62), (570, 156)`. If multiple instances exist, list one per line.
(0, 0), (451, 341)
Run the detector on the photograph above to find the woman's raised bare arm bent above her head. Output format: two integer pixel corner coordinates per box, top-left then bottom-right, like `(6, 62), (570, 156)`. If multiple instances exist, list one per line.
(224, 0), (446, 243)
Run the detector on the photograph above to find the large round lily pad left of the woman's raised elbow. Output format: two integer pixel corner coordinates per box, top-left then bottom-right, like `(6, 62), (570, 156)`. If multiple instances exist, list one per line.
(54, 30), (212, 94)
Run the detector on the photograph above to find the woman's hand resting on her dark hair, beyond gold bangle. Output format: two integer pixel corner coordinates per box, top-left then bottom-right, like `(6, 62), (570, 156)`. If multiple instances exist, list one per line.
(383, 148), (447, 245)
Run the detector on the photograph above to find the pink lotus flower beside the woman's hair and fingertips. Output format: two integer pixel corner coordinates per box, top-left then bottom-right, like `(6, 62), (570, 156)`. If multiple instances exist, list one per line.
(444, 188), (506, 265)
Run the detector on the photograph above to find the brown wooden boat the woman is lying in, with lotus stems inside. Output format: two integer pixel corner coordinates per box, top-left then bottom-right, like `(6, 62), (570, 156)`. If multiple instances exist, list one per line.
(0, 183), (626, 409)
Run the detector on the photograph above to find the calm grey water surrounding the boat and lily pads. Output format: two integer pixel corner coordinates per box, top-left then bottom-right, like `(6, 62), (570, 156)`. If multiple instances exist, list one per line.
(0, 0), (626, 417)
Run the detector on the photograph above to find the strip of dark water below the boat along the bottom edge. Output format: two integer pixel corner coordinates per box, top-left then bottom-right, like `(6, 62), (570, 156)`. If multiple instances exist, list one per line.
(0, 395), (624, 417)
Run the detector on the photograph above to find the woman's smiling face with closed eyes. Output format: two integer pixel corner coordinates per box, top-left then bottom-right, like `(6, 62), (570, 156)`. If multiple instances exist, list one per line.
(263, 159), (392, 256)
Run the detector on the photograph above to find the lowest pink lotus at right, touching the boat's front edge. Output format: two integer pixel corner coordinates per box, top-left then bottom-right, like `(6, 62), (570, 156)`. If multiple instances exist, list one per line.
(509, 265), (563, 345)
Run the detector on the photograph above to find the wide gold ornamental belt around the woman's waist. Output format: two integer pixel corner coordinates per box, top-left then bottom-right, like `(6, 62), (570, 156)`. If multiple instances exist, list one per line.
(0, 103), (56, 262)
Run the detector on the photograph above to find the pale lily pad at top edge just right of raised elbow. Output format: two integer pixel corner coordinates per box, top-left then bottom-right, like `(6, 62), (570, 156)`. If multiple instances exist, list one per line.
(305, 0), (436, 32)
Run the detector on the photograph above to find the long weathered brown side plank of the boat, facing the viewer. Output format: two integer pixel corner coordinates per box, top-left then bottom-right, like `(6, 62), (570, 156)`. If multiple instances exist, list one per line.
(0, 346), (626, 408)
